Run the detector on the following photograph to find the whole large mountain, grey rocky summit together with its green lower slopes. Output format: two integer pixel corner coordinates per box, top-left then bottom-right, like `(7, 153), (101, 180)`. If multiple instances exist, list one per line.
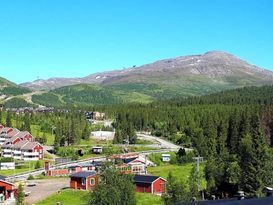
(17, 51), (273, 106)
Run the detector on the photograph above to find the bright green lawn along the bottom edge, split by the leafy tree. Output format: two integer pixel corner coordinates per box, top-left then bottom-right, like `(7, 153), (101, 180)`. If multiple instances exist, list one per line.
(36, 190), (163, 205)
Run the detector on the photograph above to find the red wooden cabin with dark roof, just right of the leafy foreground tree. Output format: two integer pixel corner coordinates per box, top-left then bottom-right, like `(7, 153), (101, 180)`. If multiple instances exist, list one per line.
(134, 175), (166, 195)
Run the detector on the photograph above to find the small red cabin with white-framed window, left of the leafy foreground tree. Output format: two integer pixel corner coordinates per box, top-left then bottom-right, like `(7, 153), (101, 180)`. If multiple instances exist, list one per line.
(70, 171), (98, 190)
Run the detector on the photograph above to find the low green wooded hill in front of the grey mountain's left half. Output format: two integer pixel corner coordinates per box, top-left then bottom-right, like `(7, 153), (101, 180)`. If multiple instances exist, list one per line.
(32, 85), (152, 107)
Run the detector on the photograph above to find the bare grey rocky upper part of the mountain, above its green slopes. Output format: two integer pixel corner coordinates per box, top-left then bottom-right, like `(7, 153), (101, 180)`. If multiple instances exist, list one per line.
(20, 51), (273, 90)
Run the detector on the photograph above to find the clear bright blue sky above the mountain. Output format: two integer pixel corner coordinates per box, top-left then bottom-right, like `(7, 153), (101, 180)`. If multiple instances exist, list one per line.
(0, 0), (273, 83)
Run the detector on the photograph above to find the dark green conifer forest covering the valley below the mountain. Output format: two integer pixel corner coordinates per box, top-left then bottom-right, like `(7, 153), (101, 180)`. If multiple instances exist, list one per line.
(0, 83), (273, 198)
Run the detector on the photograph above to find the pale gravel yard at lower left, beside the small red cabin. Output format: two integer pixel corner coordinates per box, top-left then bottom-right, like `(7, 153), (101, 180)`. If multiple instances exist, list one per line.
(25, 178), (70, 204)
